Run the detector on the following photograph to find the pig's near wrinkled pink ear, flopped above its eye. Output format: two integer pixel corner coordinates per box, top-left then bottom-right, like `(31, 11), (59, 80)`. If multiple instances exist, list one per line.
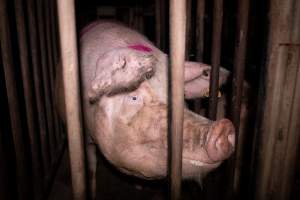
(88, 48), (157, 103)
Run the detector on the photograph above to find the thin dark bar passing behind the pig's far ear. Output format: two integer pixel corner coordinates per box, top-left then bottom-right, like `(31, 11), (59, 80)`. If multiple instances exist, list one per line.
(194, 0), (205, 114)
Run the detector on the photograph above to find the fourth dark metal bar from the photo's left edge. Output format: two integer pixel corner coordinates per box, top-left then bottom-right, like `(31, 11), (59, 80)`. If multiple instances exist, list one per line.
(36, 0), (55, 162)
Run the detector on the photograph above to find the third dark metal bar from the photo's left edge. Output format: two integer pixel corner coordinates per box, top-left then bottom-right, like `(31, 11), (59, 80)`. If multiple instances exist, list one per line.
(27, 0), (50, 173)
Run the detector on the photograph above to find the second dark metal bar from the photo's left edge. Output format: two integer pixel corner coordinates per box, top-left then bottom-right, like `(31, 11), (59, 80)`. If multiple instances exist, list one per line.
(14, 0), (43, 199)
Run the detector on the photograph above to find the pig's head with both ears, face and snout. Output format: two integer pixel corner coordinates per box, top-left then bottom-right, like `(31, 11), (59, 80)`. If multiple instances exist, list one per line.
(88, 45), (235, 182)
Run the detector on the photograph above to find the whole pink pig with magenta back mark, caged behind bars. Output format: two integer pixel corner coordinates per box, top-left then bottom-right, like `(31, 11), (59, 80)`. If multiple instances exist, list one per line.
(57, 21), (235, 198)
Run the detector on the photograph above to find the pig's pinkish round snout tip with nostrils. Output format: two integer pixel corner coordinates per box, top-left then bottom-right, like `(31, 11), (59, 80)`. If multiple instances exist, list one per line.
(207, 119), (235, 162)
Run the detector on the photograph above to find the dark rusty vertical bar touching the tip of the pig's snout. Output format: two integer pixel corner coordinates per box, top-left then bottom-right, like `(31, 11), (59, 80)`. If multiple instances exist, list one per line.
(231, 0), (249, 196)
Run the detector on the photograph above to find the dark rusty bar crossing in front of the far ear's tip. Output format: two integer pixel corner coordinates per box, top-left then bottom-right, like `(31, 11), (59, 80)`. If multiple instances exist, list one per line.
(209, 0), (223, 120)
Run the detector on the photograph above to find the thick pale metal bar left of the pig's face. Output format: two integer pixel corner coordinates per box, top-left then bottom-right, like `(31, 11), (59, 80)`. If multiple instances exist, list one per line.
(57, 0), (86, 200)
